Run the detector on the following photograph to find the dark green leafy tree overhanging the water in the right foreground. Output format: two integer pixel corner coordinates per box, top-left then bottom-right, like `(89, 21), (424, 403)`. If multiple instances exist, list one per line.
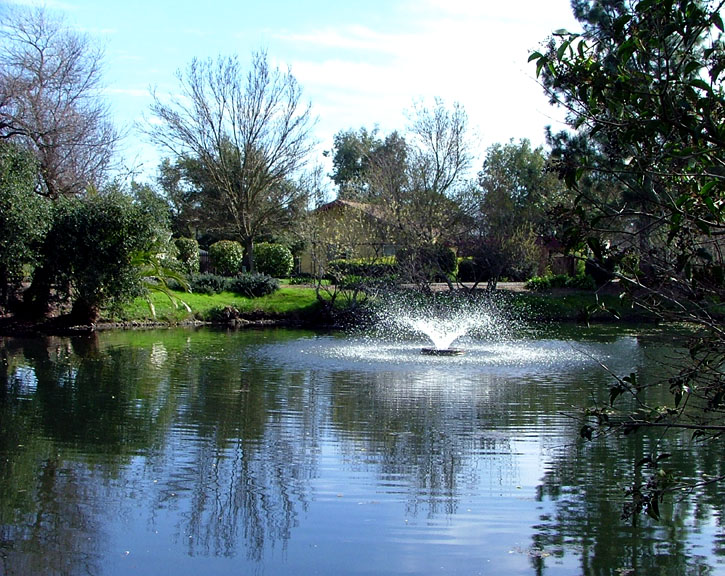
(531, 0), (725, 517)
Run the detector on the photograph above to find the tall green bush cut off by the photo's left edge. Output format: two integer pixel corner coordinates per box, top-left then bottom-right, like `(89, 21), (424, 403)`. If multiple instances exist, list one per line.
(0, 142), (50, 306)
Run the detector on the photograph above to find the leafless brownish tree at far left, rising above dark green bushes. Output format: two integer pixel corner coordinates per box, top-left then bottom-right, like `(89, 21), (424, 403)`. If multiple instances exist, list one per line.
(0, 8), (119, 197)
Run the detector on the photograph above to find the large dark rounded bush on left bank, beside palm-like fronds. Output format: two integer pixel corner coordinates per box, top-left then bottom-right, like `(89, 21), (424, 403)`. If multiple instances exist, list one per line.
(44, 189), (157, 323)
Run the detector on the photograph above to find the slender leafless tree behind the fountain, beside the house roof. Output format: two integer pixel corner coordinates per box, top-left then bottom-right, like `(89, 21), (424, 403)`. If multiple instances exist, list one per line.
(365, 99), (471, 287)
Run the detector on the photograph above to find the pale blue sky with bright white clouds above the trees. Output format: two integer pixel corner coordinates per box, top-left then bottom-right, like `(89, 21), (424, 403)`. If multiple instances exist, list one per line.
(0, 0), (577, 187)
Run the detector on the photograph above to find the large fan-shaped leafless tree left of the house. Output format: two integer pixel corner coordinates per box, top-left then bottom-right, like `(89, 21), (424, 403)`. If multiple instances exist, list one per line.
(147, 52), (314, 270)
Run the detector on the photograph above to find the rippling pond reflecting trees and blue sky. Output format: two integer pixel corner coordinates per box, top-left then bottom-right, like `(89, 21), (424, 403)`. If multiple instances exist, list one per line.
(0, 327), (725, 576)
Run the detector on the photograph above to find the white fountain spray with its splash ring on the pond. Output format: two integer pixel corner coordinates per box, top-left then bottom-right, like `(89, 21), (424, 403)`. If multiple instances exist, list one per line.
(264, 294), (604, 378)
